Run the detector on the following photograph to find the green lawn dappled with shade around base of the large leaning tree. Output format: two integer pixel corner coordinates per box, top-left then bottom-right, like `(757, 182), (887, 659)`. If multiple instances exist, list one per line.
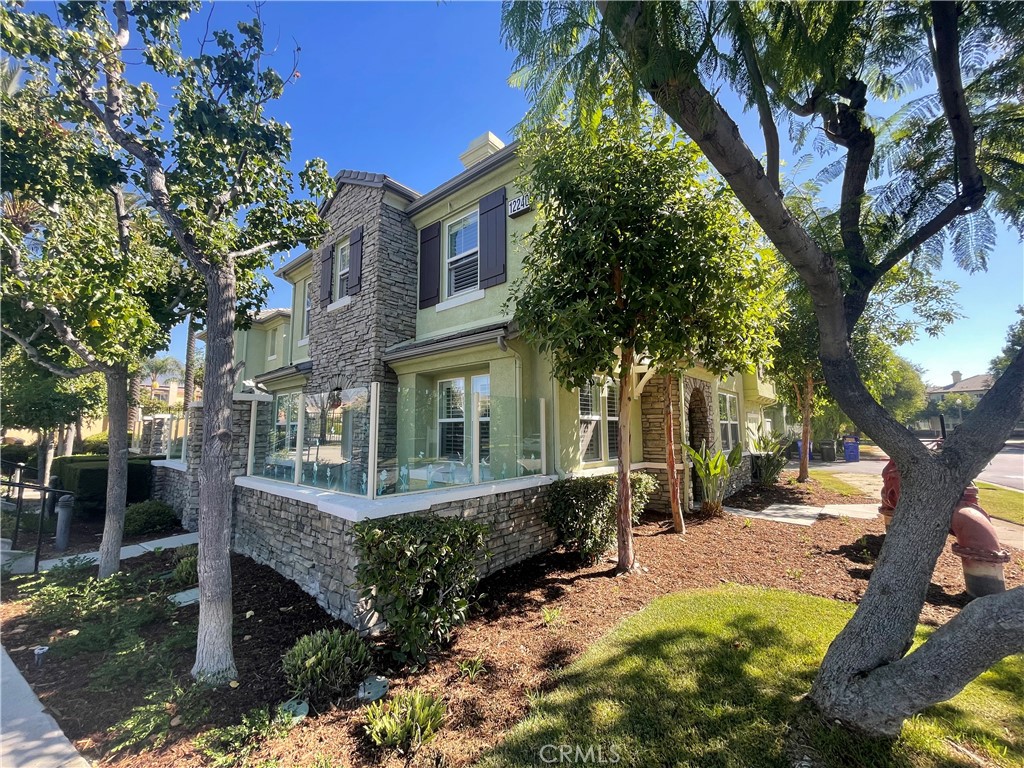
(480, 585), (1024, 768)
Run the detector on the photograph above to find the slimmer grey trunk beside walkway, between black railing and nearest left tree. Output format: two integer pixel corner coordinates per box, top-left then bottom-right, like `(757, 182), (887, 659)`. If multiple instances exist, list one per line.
(99, 366), (128, 579)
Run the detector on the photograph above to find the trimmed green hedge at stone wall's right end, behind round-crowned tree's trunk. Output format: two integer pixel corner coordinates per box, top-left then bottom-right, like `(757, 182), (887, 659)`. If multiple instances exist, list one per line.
(544, 472), (657, 562)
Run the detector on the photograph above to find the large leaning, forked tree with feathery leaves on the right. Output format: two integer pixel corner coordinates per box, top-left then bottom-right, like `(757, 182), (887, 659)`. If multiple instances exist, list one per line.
(503, 1), (1024, 734)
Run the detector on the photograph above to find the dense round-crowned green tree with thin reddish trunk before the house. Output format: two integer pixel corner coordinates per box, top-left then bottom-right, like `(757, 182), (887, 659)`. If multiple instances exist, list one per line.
(509, 102), (775, 571)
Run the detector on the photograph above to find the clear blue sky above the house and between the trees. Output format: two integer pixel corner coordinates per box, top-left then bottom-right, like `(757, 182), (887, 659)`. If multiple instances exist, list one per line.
(163, 2), (1024, 384)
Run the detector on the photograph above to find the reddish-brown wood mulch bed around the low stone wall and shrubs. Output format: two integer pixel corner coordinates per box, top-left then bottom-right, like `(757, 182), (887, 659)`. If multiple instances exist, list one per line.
(0, 507), (1024, 768)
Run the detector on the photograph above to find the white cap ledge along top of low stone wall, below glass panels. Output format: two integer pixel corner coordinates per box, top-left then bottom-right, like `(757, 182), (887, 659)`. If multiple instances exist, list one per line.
(234, 475), (558, 522)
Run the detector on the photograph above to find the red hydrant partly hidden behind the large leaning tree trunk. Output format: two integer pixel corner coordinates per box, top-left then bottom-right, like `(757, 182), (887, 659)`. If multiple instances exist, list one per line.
(879, 460), (1010, 597)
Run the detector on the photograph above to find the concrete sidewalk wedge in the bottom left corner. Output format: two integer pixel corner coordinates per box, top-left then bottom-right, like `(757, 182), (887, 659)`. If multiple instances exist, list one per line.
(0, 649), (90, 768)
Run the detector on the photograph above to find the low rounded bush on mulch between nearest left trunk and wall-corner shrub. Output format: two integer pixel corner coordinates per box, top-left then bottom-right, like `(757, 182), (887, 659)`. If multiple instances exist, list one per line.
(282, 629), (374, 707)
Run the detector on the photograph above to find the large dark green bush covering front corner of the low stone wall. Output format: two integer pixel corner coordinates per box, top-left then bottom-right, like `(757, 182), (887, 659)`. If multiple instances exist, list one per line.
(355, 515), (487, 664)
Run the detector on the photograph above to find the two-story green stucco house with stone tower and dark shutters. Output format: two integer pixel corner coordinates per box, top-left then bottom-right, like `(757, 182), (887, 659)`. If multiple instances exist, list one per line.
(151, 133), (775, 626)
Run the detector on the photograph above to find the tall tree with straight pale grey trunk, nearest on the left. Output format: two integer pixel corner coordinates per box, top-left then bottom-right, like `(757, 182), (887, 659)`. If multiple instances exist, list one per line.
(0, 0), (330, 682)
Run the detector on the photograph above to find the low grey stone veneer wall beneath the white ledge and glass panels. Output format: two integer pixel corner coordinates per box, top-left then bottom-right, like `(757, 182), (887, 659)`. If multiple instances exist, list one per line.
(231, 486), (555, 630)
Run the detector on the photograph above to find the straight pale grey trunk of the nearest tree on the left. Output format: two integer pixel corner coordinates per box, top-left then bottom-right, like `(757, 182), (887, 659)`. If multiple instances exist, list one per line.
(191, 260), (238, 684)
